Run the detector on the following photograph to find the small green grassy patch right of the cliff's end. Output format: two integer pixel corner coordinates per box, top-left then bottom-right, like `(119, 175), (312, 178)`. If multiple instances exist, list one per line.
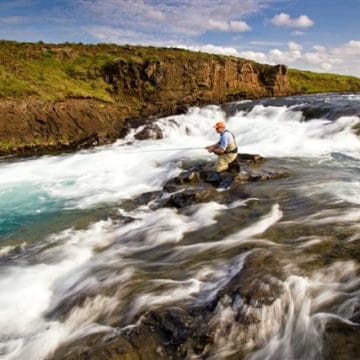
(288, 69), (360, 94)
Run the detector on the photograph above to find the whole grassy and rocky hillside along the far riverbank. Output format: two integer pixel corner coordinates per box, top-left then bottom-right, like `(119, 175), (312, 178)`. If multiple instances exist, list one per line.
(0, 41), (360, 154)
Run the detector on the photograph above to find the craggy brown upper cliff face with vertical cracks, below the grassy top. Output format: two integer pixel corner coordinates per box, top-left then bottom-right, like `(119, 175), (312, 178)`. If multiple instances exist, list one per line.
(104, 58), (290, 112)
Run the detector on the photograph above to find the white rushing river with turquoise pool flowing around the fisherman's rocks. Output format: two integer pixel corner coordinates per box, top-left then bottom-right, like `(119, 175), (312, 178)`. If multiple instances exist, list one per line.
(0, 94), (360, 360)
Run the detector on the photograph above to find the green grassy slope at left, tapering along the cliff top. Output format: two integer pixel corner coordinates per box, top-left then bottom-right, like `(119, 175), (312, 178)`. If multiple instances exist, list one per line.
(0, 41), (233, 102)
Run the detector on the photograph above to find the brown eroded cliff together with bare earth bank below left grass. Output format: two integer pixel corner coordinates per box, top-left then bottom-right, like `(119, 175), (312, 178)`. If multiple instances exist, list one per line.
(0, 54), (291, 155)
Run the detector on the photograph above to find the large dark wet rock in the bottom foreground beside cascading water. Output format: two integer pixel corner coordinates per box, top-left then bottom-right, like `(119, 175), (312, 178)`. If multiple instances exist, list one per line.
(52, 251), (284, 360)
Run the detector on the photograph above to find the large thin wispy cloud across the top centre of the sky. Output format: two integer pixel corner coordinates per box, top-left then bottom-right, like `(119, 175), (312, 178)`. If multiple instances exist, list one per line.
(74, 0), (279, 41)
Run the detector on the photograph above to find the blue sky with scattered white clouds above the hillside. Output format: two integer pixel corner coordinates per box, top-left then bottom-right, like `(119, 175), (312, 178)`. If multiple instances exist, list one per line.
(0, 0), (360, 77)
